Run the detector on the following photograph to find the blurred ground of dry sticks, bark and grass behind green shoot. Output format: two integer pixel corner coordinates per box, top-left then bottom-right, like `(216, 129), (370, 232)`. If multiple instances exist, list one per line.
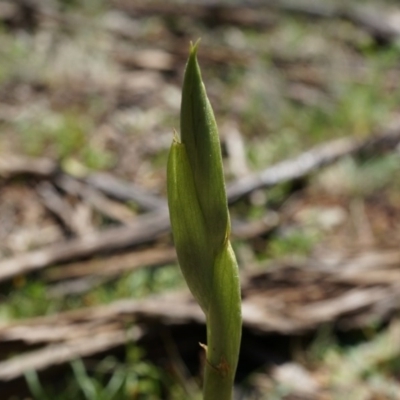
(0, 0), (400, 400)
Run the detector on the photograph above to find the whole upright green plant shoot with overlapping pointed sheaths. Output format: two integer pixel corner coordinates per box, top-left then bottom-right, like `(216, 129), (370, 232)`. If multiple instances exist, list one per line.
(167, 41), (242, 400)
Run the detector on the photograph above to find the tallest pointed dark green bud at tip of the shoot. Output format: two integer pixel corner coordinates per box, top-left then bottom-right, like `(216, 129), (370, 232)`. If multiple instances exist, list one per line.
(181, 45), (230, 254)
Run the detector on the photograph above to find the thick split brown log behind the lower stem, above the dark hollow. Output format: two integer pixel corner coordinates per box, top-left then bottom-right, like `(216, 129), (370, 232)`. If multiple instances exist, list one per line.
(0, 251), (400, 382)
